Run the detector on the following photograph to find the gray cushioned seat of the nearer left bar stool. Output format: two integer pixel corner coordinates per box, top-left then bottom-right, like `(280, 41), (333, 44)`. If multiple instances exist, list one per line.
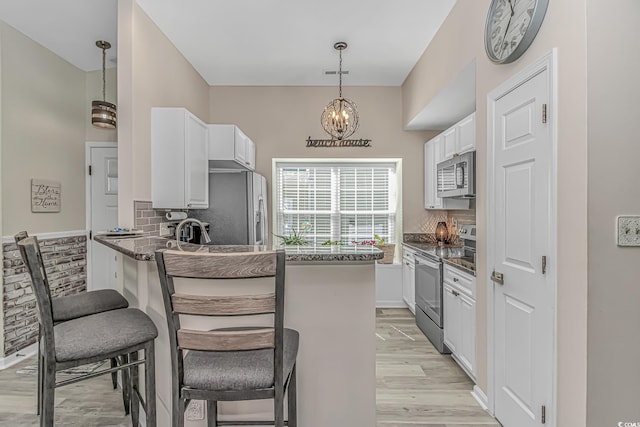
(53, 308), (158, 362)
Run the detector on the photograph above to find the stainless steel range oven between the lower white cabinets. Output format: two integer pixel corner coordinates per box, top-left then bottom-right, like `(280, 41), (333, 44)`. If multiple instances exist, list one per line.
(415, 253), (451, 353)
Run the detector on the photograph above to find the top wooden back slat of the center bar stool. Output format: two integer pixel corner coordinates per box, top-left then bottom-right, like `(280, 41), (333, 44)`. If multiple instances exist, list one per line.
(164, 251), (276, 279)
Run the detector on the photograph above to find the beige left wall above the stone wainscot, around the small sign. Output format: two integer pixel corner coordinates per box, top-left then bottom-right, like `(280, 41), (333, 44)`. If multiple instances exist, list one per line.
(0, 21), (89, 235)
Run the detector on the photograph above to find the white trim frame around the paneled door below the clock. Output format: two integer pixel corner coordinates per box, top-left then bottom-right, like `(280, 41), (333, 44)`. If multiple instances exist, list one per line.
(485, 48), (558, 427)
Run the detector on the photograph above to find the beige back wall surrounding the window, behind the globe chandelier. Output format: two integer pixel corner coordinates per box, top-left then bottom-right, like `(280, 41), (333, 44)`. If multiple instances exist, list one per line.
(209, 86), (435, 231)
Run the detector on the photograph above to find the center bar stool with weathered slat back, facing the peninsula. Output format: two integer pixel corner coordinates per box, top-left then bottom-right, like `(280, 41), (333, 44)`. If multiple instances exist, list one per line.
(156, 250), (299, 427)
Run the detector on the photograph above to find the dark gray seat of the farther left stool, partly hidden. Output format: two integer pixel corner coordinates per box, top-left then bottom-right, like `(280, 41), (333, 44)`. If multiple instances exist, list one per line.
(51, 289), (129, 323)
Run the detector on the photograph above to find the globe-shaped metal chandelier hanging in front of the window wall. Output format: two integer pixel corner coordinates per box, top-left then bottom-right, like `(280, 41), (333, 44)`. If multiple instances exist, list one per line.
(320, 42), (358, 140)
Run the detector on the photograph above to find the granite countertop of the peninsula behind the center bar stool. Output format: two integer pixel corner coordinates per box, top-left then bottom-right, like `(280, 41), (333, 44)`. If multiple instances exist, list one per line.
(93, 236), (384, 262)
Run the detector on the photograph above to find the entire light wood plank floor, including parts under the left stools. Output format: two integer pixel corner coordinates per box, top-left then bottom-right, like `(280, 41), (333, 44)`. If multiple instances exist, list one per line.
(0, 309), (500, 427)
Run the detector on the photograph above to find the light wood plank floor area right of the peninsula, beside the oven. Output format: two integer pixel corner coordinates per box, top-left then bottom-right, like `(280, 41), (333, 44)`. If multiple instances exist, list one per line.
(376, 309), (500, 427)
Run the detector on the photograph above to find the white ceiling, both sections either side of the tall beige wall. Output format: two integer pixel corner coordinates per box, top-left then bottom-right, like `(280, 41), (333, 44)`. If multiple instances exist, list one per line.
(0, 0), (456, 86)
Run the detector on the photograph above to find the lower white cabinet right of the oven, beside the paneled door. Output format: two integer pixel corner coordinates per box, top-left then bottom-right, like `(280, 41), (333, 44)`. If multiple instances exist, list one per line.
(443, 264), (476, 381)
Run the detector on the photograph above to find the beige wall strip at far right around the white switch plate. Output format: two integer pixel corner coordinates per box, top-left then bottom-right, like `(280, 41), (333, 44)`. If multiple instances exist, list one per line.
(587, 0), (640, 427)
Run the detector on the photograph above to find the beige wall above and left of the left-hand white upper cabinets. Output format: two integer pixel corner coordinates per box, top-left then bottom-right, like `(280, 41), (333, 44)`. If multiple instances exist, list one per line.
(118, 0), (209, 226)
